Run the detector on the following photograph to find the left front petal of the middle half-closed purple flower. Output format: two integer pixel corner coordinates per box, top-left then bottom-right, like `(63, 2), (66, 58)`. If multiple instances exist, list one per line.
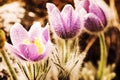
(49, 9), (66, 38)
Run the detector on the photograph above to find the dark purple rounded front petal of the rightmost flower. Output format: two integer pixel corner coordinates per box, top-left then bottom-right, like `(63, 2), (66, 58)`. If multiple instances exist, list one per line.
(84, 13), (104, 32)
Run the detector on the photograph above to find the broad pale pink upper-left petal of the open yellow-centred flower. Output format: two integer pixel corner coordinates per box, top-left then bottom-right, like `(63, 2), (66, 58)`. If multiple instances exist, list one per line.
(10, 23), (28, 47)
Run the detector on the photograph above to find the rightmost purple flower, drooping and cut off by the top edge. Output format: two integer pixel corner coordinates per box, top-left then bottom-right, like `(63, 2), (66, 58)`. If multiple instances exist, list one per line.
(76, 0), (107, 32)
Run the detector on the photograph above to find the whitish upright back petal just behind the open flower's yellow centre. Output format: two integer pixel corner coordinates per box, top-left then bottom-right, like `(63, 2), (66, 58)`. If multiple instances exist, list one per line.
(29, 22), (42, 40)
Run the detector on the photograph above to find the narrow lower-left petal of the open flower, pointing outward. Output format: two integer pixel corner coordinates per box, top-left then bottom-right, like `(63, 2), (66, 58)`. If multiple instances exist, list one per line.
(5, 43), (27, 61)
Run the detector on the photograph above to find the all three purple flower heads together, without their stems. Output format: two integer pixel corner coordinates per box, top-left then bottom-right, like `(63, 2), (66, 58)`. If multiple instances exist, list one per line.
(6, 0), (107, 61)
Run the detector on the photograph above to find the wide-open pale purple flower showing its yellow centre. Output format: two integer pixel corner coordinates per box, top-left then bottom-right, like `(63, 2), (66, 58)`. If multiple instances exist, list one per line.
(6, 23), (51, 61)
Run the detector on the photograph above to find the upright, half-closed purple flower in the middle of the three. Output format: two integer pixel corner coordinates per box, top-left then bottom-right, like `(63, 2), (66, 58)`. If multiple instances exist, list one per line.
(47, 3), (81, 39)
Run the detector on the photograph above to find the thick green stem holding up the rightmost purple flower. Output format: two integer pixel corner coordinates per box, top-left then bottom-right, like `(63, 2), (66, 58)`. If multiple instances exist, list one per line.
(97, 32), (107, 80)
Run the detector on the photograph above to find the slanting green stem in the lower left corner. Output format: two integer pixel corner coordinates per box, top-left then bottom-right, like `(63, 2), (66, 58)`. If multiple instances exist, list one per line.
(1, 50), (18, 80)
